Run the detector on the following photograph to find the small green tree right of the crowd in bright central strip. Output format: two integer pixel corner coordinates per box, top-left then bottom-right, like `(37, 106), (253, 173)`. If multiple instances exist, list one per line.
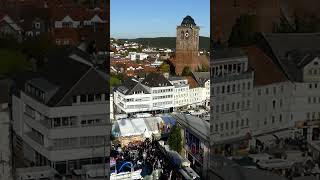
(168, 124), (182, 153)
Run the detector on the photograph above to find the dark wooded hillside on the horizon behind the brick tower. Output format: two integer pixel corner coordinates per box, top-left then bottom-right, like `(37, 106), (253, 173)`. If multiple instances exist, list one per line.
(119, 36), (210, 49)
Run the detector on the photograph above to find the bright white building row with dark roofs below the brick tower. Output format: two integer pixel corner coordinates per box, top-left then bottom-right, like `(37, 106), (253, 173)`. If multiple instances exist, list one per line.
(113, 73), (210, 114)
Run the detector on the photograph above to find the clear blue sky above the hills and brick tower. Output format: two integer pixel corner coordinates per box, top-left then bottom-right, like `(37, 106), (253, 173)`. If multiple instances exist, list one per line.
(110, 0), (210, 38)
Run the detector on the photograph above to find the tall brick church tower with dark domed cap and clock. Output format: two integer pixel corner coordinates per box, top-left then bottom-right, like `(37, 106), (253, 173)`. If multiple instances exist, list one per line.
(174, 16), (200, 75)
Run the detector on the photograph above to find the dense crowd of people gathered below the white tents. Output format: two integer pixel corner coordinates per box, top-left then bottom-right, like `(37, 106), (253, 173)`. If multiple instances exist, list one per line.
(112, 139), (178, 180)
